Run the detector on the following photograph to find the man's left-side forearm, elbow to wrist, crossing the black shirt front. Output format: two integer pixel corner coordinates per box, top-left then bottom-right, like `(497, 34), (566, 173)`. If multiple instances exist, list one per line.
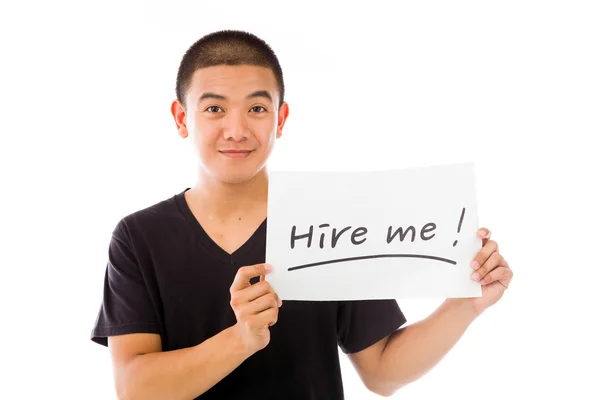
(117, 328), (250, 400)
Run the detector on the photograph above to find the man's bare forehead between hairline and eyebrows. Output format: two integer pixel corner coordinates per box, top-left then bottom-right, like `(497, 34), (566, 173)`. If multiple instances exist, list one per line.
(188, 65), (278, 99)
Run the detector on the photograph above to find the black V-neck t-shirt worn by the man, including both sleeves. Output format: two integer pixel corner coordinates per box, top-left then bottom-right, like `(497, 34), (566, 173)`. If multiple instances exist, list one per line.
(91, 188), (406, 400)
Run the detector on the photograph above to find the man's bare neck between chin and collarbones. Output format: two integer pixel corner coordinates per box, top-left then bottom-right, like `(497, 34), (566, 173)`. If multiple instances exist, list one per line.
(188, 167), (268, 221)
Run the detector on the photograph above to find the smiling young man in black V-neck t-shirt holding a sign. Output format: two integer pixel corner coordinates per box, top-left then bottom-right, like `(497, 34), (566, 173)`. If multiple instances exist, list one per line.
(92, 31), (512, 400)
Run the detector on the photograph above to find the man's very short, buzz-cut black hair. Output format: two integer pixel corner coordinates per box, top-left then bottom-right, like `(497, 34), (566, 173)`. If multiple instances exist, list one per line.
(175, 30), (285, 108)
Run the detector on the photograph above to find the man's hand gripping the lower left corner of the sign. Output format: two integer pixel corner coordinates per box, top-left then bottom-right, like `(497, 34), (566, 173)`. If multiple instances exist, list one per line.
(229, 264), (282, 354)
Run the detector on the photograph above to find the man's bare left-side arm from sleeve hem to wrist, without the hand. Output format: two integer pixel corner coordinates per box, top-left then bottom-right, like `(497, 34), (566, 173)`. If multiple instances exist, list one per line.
(108, 327), (251, 400)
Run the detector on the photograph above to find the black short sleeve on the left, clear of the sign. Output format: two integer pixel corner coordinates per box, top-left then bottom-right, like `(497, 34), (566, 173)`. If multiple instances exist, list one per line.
(91, 220), (160, 346)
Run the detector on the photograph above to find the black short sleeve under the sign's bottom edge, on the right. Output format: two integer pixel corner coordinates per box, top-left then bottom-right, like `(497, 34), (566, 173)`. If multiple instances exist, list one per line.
(337, 300), (406, 354)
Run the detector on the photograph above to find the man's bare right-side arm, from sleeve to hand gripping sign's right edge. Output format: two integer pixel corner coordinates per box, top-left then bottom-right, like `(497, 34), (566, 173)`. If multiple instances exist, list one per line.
(350, 228), (513, 396)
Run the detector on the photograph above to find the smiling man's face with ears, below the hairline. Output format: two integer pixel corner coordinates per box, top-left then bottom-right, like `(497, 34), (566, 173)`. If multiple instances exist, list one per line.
(171, 65), (288, 183)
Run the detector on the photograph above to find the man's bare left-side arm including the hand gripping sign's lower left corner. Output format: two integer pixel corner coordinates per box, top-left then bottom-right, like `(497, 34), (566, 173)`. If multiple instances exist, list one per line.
(108, 264), (282, 400)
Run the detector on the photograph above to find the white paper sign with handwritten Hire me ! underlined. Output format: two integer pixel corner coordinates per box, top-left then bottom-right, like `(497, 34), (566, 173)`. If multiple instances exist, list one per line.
(266, 163), (482, 300)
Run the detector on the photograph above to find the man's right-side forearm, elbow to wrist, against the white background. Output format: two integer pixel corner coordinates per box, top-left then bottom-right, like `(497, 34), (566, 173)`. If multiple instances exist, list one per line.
(377, 299), (477, 393)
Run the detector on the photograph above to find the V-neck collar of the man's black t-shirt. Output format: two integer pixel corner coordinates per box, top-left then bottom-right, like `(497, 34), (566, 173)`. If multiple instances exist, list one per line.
(175, 188), (267, 264)
